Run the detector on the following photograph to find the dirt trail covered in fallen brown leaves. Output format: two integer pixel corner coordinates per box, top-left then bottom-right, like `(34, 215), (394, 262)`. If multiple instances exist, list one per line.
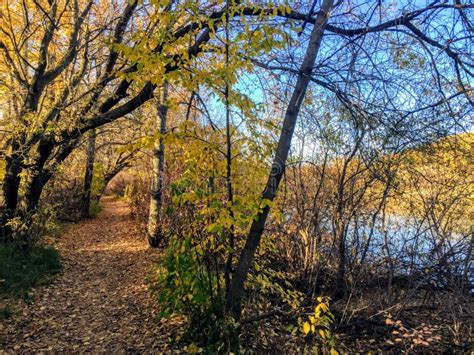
(0, 199), (164, 353)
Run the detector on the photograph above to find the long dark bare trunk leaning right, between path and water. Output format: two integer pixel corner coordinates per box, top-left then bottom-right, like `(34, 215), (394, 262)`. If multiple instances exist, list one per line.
(226, 0), (333, 320)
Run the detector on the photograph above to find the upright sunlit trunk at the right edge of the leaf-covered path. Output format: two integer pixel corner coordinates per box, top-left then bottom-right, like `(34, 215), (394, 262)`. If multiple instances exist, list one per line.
(147, 82), (168, 248)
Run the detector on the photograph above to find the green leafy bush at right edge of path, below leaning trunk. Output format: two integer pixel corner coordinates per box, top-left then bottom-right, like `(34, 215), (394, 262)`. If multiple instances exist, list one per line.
(150, 237), (238, 353)
